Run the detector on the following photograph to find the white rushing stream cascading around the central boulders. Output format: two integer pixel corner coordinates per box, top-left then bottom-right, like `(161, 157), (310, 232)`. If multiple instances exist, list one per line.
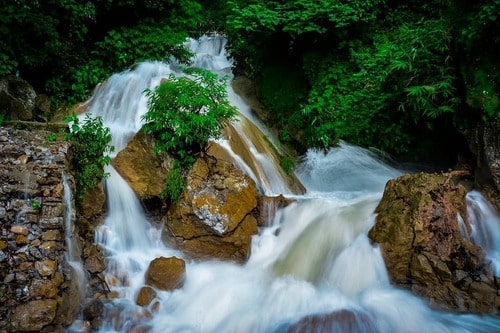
(72, 37), (500, 333)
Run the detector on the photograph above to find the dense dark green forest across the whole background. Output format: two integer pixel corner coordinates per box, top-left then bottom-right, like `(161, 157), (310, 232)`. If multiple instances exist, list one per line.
(0, 0), (500, 163)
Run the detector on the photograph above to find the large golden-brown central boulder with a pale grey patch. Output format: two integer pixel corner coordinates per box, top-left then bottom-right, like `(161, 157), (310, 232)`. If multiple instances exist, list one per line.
(164, 150), (258, 263)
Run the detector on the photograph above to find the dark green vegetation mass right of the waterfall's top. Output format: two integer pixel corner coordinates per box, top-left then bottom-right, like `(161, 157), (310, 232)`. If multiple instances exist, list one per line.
(226, 0), (500, 160)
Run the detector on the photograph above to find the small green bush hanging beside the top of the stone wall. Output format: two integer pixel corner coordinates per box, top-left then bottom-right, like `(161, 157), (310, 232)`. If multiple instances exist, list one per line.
(65, 114), (114, 202)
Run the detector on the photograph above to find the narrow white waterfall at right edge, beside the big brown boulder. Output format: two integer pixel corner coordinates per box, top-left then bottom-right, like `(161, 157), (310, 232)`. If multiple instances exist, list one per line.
(465, 191), (500, 276)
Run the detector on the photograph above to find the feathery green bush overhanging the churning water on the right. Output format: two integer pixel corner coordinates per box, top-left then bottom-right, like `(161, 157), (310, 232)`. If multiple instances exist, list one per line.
(298, 16), (459, 155)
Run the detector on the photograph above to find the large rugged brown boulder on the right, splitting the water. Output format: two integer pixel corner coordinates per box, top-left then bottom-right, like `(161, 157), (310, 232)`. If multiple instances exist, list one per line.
(369, 173), (500, 313)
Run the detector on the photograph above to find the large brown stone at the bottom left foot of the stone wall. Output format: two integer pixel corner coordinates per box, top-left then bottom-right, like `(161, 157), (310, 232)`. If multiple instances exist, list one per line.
(11, 299), (57, 332)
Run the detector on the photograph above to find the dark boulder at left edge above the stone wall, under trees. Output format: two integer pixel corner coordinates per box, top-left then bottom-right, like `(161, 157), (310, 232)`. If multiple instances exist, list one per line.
(0, 76), (36, 120)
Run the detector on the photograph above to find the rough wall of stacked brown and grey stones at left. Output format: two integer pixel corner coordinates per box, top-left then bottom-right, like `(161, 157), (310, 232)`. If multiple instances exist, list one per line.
(0, 127), (79, 332)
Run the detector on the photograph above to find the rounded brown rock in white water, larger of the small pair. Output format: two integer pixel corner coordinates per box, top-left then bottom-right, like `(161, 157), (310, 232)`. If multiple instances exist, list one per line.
(146, 257), (186, 290)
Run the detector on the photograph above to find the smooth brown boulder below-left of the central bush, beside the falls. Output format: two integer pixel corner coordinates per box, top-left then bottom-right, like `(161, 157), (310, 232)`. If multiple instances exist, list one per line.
(113, 132), (173, 199)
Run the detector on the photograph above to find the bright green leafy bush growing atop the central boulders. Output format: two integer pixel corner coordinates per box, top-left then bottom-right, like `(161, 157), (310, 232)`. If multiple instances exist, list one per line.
(143, 69), (236, 165)
